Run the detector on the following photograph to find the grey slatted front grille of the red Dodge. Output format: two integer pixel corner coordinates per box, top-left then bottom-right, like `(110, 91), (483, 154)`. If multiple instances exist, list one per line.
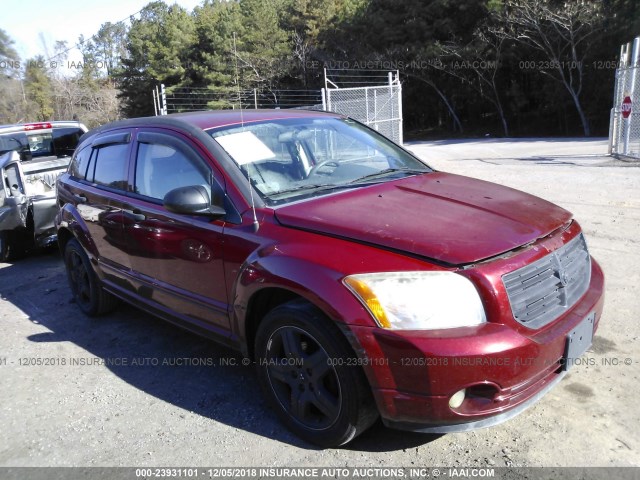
(502, 234), (591, 328)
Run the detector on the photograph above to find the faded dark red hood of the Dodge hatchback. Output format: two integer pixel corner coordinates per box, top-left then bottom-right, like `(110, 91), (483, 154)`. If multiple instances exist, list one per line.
(275, 172), (571, 265)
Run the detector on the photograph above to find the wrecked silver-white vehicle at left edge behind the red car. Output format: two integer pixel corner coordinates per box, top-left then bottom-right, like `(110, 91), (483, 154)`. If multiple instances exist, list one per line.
(0, 122), (87, 262)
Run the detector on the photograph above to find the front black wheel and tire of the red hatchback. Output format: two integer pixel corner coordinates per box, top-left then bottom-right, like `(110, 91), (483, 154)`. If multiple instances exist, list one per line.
(255, 300), (378, 447)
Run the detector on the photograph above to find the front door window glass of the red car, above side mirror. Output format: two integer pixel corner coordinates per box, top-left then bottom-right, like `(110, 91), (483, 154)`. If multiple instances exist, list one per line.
(134, 135), (211, 201)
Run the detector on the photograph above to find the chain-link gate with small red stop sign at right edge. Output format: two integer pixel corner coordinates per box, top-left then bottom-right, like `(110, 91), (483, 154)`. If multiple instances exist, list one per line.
(609, 37), (640, 160)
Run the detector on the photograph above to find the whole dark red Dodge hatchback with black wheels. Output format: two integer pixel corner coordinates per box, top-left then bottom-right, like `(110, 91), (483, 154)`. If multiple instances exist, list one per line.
(56, 110), (604, 446)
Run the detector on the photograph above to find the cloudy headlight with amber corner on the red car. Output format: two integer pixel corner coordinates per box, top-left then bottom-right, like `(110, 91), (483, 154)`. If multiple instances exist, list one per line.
(344, 272), (487, 330)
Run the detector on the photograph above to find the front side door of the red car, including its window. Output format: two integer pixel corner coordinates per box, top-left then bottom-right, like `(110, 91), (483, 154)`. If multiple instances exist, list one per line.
(125, 129), (229, 335)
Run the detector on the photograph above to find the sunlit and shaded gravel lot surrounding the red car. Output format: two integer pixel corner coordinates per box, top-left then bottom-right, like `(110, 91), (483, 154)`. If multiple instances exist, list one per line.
(0, 140), (640, 467)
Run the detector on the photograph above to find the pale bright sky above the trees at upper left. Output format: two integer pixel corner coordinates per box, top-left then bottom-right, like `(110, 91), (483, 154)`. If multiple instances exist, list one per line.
(0, 0), (203, 61)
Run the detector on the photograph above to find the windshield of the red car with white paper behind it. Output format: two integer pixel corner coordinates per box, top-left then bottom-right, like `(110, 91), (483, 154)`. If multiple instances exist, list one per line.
(207, 117), (431, 205)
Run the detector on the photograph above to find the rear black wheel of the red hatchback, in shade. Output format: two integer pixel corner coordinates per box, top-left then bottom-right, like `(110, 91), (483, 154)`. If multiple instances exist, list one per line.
(64, 238), (119, 317)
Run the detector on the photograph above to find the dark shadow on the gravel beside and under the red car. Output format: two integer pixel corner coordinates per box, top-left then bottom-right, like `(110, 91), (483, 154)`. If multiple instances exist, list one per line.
(0, 252), (438, 452)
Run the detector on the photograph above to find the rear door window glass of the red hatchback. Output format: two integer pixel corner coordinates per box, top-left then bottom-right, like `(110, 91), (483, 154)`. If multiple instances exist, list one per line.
(85, 143), (129, 190)
